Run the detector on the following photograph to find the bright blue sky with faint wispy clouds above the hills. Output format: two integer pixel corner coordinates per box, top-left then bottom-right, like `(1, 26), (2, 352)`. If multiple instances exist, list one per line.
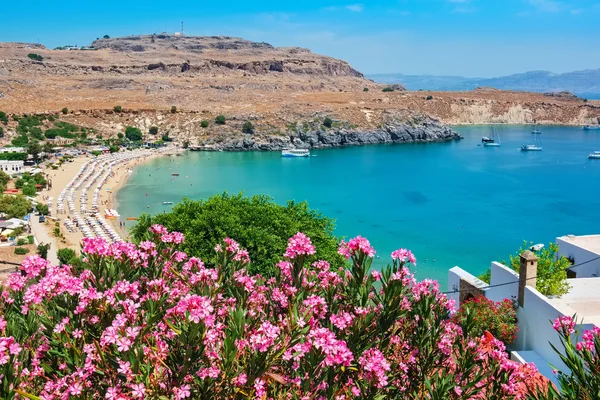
(0, 0), (600, 78)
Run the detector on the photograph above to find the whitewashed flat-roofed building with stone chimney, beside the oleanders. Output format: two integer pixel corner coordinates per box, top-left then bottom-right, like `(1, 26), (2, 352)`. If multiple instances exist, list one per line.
(448, 235), (600, 383)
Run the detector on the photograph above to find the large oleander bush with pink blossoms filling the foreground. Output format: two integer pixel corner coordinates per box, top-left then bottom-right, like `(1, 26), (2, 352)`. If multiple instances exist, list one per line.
(0, 225), (538, 400)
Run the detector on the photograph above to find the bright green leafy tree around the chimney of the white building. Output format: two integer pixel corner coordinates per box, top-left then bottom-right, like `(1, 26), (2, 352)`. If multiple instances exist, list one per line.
(479, 241), (571, 296)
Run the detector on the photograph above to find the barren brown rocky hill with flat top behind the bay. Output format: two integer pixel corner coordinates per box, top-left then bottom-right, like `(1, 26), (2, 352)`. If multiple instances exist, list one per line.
(0, 34), (600, 148)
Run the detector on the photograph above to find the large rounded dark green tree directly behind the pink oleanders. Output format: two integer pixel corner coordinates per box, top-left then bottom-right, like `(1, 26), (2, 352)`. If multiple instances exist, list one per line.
(131, 193), (343, 276)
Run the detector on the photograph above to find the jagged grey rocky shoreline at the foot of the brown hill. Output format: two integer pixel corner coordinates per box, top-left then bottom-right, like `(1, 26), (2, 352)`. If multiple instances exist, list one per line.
(191, 118), (462, 151)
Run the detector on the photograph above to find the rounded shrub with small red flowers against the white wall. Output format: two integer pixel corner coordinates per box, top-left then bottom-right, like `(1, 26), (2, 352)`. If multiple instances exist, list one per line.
(454, 296), (519, 345)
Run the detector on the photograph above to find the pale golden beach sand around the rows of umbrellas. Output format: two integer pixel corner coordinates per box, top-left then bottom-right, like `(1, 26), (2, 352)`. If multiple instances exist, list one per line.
(35, 148), (181, 252)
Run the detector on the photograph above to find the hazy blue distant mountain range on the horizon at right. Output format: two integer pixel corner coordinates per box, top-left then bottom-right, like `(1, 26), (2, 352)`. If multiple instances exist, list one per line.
(367, 69), (600, 97)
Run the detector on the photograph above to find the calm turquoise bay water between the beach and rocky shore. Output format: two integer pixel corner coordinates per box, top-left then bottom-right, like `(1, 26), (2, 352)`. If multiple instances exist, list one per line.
(118, 126), (600, 282)
